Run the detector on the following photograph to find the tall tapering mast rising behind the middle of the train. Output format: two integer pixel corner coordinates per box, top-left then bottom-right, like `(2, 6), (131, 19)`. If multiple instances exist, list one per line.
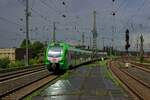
(92, 11), (97, 57)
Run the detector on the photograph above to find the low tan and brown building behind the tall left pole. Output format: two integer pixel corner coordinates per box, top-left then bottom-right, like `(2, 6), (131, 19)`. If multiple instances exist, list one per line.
(0, 48), (32, 62)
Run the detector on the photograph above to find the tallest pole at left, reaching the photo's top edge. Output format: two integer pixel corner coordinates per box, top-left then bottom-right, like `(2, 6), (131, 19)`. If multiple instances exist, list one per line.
(25, 0), (30, 66)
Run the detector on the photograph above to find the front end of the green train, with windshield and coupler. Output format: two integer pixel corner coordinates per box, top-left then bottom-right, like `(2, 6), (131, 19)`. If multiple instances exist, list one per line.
(46, 46), (64, 72)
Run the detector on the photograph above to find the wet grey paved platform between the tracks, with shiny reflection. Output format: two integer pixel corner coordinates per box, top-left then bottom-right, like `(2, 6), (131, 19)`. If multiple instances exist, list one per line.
(32, 64), (131, 100)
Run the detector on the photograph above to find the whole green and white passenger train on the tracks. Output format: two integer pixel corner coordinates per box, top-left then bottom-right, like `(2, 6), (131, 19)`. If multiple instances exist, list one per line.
(45, 43), (105, 73)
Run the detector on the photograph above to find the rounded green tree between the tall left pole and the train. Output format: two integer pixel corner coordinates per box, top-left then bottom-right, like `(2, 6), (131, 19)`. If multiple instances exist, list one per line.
(31, 41), (44, 57)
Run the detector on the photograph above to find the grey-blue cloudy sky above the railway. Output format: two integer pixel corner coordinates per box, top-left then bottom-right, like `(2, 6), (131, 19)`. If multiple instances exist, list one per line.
(0, 0), (150, 50)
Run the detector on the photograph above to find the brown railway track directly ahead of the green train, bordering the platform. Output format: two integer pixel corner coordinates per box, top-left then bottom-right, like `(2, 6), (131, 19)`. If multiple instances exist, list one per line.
(1, 75), (58, 100)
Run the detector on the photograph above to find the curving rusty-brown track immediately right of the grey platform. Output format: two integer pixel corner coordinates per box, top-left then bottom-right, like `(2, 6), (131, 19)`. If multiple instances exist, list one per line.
(110, 62), (150, 100)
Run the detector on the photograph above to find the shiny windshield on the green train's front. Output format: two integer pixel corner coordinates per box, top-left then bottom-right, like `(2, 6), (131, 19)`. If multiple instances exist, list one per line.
(48, 47), (63, 57)
